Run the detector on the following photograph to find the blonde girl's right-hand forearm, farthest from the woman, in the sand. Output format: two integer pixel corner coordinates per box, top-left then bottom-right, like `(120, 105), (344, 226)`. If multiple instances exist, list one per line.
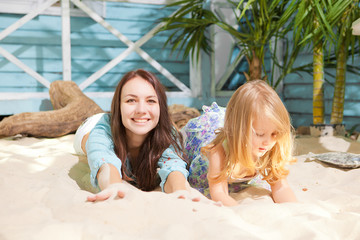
(270, 178), (297, 203)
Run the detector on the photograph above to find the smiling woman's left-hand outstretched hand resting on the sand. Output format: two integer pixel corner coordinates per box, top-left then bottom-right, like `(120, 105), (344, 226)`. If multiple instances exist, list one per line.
(87, 182), (130, 202)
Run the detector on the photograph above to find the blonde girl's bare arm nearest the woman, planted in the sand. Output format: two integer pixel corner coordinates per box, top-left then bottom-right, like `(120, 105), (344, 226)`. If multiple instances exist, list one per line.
(207, 145), (237, 206)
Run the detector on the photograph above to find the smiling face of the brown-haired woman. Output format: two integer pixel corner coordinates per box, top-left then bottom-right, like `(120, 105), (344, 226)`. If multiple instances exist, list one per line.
(120, 76), (160, 142)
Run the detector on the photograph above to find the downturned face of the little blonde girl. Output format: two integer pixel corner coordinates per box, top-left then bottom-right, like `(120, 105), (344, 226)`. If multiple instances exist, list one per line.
(252, 117), (278, 159)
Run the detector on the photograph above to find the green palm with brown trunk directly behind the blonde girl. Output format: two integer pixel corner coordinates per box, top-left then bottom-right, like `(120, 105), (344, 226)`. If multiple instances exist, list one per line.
(160, 0), (297, 86)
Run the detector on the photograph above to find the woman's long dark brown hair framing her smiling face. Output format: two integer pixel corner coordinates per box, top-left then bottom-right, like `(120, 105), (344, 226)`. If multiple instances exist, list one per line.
(110, 69), (184, 191)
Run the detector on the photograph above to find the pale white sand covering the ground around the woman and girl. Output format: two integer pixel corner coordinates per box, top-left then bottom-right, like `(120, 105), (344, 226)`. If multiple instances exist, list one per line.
(0, 135), (360, 240)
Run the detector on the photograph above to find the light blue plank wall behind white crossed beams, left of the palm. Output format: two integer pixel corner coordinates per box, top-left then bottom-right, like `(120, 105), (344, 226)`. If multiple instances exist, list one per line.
(0, 2), (189, 115)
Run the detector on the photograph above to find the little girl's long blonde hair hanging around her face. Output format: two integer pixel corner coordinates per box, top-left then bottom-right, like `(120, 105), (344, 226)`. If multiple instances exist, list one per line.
(201, 80), (294, 183)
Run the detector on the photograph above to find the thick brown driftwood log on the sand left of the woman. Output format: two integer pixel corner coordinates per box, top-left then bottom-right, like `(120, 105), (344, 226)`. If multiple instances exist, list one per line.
(0, 81), (104, 137)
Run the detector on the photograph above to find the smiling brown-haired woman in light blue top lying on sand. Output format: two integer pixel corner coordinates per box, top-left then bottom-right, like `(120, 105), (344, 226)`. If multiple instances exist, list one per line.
(74, 69), (200, 201)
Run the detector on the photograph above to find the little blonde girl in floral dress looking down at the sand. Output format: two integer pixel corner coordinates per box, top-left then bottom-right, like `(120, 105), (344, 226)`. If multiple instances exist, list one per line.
(182, 80), (296, 206)
